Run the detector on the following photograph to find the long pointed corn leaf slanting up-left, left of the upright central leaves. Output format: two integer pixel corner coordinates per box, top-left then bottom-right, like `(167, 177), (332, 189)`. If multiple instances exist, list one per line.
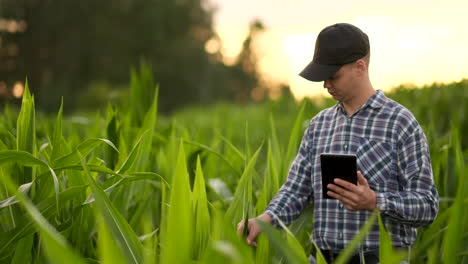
(77, 151), (143, 263)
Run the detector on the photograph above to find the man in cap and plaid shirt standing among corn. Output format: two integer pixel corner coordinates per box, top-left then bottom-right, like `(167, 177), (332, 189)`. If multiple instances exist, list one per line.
(238, 23), (439, 263)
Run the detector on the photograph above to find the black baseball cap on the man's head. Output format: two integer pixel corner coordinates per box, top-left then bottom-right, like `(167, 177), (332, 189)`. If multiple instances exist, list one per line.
(299, 23), (370, 82)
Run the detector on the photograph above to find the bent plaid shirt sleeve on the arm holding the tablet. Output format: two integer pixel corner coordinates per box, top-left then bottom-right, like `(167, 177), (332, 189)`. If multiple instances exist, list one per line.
(377, 127), (439, 227)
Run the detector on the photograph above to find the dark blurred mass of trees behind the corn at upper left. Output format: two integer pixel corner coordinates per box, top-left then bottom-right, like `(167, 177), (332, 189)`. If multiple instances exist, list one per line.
(0, 0), (264, 111)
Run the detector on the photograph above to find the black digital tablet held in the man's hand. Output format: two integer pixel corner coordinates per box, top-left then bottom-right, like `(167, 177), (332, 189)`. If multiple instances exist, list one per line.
(320, 153), (357, 199)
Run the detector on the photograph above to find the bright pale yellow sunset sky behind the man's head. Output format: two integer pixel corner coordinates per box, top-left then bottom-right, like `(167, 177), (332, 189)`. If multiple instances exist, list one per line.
(207, 0), (468, 98)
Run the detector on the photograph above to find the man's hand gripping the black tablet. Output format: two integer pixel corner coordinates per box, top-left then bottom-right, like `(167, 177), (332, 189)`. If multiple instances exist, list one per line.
(327, 171), (377, 211)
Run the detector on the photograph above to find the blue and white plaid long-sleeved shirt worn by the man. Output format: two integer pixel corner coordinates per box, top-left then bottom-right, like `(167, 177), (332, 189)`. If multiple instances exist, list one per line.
(265, 91), (438, 250)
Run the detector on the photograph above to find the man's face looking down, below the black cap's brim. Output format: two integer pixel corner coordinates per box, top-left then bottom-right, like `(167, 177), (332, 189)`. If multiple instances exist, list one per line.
(323, 63), (356, 102)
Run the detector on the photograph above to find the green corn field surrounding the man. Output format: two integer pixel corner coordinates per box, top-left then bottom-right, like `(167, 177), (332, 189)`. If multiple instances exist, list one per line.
(0, 67), (468, 264)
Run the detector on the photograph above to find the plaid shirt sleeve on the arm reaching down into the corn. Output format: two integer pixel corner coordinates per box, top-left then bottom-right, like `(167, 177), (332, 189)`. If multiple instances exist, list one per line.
(265, 123), (313, 227)
